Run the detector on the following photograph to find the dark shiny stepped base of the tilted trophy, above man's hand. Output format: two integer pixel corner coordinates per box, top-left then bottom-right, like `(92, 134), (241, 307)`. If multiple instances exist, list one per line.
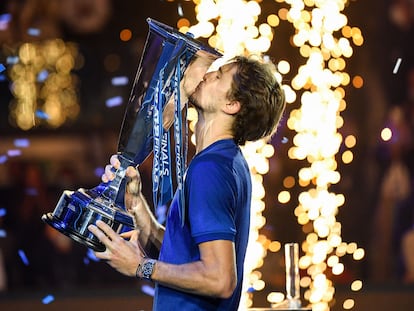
(42, 189), (134, 252)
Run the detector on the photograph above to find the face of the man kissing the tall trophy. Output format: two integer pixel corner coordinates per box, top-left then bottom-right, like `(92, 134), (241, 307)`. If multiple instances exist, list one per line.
(190, 61), (237, 112)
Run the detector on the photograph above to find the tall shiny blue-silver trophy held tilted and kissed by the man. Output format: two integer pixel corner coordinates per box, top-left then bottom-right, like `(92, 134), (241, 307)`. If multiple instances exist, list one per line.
(42, 18), (221, 252)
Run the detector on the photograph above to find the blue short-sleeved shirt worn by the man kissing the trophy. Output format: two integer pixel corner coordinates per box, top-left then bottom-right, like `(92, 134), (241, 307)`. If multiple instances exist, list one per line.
(153, 139), (252, 311)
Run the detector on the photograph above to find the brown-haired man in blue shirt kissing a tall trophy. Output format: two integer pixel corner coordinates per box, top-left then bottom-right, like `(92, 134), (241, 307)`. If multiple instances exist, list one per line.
(89, 57), (285, 311)
